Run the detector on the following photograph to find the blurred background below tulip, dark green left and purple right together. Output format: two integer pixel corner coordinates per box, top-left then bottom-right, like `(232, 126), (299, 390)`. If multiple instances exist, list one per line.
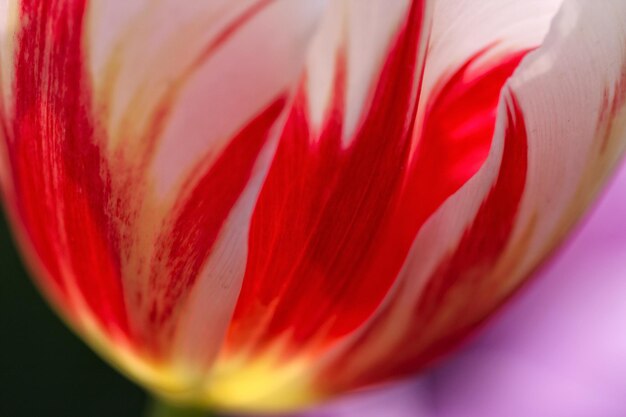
(0, 158), (626, 417)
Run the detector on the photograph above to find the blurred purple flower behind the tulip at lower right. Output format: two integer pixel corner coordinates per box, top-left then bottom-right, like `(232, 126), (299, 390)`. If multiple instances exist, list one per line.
(294, 148), (626, 417)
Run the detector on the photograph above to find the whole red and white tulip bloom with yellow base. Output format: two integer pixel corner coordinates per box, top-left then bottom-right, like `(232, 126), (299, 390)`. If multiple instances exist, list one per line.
(0, 0), (626, 411)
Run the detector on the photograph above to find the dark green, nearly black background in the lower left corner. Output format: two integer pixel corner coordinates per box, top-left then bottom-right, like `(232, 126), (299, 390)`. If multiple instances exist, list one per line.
(0, 213), (145, 417)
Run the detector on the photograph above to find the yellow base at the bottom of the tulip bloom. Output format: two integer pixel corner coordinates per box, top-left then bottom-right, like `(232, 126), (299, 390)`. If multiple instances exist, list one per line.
(80, 315), (322, 413)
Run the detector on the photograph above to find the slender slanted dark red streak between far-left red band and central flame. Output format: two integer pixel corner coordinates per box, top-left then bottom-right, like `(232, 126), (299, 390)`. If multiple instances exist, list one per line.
(148, 97), (286, 344)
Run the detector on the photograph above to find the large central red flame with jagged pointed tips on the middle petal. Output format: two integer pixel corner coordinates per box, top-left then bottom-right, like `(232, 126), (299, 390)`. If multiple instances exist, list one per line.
(229, 1), (423, 348)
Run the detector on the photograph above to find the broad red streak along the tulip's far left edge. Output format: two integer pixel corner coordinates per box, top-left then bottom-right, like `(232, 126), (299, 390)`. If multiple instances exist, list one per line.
(8, 0), (128, 333)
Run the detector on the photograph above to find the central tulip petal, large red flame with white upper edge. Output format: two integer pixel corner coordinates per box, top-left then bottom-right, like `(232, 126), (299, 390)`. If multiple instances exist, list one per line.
(226, 0), (429, 356)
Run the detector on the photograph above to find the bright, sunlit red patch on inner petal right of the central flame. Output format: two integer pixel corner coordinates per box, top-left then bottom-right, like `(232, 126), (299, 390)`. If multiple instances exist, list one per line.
(407, 50), (529, 201)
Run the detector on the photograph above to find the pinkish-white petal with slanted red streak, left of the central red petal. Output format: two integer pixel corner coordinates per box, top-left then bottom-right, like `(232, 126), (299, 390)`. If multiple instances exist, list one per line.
(86, 0), (325, 364)
